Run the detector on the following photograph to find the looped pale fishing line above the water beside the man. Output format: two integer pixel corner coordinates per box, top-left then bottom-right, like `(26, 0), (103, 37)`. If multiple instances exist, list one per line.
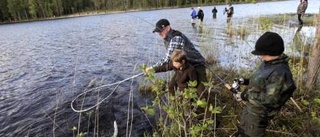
(71, 73), (144, 113)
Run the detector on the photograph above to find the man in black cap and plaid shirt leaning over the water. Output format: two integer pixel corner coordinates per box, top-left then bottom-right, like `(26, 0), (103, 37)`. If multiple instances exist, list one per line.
(146, 19), (208, 103)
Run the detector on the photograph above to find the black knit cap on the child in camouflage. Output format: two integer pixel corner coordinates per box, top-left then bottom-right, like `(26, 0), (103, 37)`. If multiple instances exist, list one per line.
(251, 32), (284, 56)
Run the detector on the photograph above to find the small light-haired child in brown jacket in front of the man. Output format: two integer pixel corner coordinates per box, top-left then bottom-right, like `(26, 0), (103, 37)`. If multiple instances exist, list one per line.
(153, 49), (197, 95)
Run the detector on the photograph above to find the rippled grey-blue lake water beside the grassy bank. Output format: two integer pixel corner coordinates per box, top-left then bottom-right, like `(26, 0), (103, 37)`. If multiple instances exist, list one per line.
(0, 0), (320, 137)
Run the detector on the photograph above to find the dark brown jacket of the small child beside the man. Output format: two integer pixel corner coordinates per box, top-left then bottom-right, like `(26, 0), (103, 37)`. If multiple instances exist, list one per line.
(153, 61), (197, 95)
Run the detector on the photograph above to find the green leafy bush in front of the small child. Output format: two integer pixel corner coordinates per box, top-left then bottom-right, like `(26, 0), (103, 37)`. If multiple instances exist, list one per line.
(142, 66), (221, 137)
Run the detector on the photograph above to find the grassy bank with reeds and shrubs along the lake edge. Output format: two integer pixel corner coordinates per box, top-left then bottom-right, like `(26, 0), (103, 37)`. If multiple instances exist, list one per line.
(140, 14), (320, 137)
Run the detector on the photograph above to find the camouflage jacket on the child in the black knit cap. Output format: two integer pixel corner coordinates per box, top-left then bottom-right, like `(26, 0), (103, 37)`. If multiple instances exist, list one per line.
(241, 54), (296, 117)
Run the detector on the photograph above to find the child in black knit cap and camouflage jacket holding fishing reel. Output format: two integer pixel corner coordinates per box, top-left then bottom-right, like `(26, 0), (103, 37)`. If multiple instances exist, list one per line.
(233, 32), (296, 137)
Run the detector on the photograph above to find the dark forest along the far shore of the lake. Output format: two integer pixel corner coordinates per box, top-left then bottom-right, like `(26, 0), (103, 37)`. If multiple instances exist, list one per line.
(0, 0), (269, 23)
